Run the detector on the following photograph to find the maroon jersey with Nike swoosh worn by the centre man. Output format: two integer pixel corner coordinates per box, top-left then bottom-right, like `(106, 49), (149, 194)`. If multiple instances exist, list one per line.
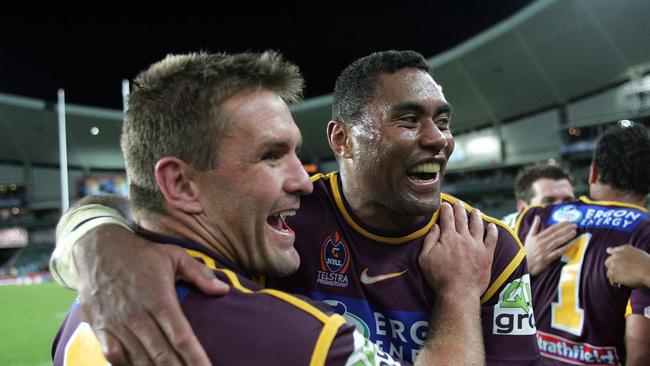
(268, 173), (539, 365)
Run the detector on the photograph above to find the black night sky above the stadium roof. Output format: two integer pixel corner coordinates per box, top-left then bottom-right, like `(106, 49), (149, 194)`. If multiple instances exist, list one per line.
(0, 0), (531, 108)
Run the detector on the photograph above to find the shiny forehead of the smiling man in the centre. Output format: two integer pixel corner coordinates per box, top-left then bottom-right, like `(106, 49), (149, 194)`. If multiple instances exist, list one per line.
(372, 68), (447, 108)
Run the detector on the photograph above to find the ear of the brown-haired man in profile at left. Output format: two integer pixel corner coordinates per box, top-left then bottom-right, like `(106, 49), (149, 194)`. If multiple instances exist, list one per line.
(155, 156), (203, 214)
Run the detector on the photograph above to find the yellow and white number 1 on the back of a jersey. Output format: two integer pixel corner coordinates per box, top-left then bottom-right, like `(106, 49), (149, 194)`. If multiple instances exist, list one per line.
(551, 233), (591, 336)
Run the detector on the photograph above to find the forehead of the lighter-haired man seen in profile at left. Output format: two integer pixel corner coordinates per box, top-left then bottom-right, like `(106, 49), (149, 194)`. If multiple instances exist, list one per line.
(220, 91), (300, 146)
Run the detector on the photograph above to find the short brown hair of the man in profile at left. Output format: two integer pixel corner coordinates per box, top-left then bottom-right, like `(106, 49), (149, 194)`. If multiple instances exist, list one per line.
(121, 51), (304, 213)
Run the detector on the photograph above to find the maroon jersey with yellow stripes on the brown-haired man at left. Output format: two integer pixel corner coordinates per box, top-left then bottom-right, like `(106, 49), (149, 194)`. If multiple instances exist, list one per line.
(52, 235), (404, 366)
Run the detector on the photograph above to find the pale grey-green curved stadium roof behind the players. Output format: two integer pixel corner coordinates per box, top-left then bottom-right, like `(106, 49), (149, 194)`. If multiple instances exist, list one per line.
(0, 0), (650, 170)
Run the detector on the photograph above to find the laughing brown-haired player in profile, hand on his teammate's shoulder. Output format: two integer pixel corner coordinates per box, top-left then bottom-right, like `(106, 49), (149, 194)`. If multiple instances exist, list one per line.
(54, 52), (497, 365)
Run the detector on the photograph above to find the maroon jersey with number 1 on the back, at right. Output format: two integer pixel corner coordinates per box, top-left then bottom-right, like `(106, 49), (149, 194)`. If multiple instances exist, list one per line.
(515, 197), (650, 365)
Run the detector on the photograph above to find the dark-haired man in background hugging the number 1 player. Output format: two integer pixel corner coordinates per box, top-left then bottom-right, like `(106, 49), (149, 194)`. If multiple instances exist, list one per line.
(503, 164), (576, 276)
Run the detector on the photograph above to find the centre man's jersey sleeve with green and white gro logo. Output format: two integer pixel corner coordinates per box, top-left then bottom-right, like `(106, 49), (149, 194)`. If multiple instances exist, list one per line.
(481, 220), (540, 365)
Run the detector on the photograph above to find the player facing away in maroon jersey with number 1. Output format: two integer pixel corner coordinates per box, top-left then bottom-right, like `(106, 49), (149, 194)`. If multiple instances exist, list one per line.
(516, 121), (650, 366)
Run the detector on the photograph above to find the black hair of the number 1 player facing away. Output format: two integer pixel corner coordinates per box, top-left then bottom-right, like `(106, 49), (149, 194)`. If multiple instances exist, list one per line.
(594, 121), (650, 195)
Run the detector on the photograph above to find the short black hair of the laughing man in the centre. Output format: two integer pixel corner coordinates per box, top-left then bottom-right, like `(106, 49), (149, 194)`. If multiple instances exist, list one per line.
(332, 50), (431, 124)
